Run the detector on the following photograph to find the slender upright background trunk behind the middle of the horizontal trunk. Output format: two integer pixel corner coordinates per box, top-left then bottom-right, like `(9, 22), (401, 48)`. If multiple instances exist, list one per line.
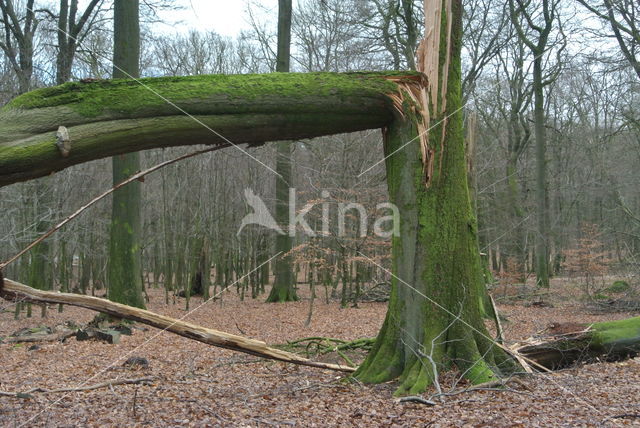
(267, 0), (298, 302)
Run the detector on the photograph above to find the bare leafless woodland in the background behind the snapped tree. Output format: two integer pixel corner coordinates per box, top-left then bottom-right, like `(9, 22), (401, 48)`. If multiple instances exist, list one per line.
(0, 0), (640, 310)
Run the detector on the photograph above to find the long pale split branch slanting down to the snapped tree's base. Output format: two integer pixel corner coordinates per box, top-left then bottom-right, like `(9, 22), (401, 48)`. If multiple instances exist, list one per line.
(0, 278), (355, 373)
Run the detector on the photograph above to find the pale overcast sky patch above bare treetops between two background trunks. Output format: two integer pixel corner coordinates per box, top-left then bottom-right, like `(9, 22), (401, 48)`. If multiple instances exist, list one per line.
(154, 0), (278, 37)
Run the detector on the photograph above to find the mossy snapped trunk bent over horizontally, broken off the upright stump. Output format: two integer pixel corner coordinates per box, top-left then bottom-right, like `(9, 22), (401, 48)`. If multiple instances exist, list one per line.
(0, 72), (410, 186)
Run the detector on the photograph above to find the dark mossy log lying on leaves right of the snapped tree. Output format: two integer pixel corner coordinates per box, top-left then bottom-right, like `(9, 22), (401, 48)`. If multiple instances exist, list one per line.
(512, 317), (640, 369)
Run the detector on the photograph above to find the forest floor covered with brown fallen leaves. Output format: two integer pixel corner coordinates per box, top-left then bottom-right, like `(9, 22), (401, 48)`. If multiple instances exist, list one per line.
(0, 280), (640, 427)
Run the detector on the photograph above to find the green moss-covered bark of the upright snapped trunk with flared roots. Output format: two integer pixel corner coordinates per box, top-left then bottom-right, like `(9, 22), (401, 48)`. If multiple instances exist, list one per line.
(356, 1), (514, 394)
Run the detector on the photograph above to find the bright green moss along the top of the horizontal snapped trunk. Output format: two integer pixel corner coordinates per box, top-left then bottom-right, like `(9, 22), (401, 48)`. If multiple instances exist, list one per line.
(3, 72), (408, 117)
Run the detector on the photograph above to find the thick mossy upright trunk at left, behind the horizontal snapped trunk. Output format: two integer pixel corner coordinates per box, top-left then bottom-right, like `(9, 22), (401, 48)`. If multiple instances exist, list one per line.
(108, 0), (144, 308)
